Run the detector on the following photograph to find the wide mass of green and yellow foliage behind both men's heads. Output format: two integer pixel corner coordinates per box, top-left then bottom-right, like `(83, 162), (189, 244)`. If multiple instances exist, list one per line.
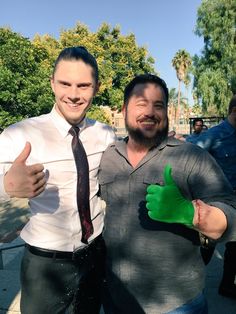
(0, 22), (155, 126)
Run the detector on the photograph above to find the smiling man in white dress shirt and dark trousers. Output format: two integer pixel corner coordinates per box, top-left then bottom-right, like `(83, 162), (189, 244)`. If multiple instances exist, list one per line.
(0, 47), (115, 314)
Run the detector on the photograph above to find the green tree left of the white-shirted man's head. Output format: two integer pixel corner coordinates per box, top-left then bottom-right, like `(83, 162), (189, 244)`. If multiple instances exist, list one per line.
(0, 28), (49, 126)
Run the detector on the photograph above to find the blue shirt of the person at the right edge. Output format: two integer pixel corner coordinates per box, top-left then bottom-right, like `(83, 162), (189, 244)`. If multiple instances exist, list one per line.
(196, 119), (236, 189)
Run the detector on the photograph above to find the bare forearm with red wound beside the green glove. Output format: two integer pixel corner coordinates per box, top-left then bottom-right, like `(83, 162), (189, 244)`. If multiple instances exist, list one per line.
(192, 200), (227, 240)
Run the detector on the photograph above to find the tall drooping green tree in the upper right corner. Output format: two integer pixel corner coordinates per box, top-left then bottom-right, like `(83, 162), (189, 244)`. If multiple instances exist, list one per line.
(193, 0), (236, 114)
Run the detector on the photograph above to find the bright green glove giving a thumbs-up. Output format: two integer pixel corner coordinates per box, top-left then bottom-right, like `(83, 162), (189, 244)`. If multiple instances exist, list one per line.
(146, 165), (194, 227)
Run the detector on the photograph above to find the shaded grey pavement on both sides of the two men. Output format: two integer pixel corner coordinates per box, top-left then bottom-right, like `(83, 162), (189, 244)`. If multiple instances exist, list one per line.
(0, 199), (236, 314)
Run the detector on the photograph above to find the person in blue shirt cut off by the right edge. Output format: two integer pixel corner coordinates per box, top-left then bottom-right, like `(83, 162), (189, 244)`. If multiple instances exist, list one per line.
(196, 95), (236, 299)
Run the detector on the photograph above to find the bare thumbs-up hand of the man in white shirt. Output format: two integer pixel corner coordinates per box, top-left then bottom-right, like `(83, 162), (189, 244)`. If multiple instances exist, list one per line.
(4, 142), (46, 198)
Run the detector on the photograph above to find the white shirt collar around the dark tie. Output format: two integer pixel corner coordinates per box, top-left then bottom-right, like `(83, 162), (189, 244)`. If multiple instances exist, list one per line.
(50, 105), (89, 137)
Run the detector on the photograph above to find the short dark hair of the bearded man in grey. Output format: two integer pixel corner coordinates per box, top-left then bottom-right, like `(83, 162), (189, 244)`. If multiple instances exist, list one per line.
(124, 73), (169, 106)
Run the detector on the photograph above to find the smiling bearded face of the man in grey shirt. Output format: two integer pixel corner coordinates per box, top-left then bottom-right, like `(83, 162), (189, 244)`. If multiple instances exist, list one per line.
(123, 83), (168, 147)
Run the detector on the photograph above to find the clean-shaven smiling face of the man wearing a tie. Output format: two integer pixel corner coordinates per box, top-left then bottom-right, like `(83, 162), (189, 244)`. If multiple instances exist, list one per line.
(51, 60), (98, 124)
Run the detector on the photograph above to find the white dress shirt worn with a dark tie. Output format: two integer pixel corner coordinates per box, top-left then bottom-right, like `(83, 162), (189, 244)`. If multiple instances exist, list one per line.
(0, 108), (115, 251)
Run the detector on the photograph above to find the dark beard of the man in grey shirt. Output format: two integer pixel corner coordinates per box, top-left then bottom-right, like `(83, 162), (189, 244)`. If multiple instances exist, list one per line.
(125, 117), (169, 148)
